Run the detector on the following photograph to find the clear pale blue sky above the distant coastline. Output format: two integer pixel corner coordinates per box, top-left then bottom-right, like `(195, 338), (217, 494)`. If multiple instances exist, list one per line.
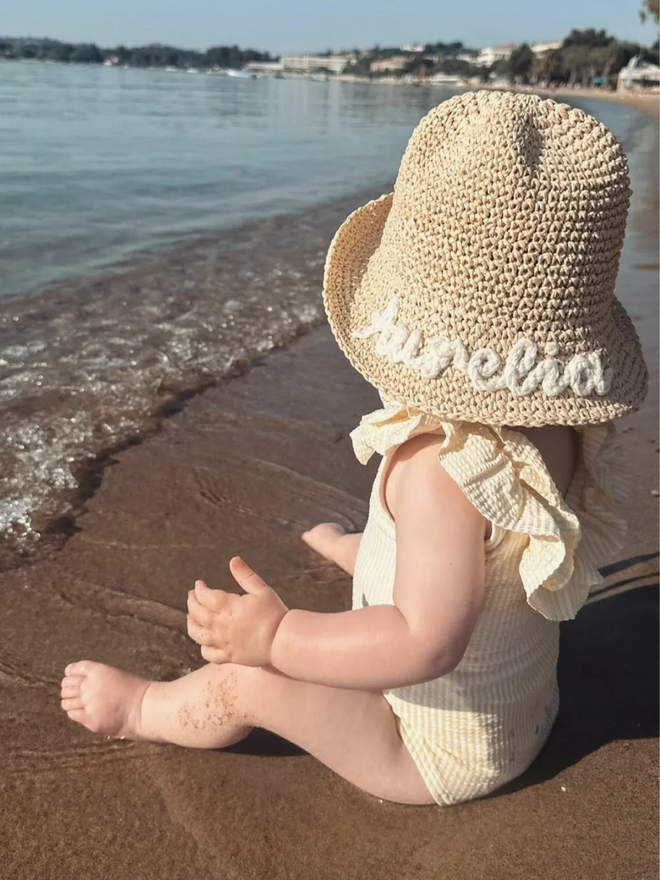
(0, 0), (657, 54)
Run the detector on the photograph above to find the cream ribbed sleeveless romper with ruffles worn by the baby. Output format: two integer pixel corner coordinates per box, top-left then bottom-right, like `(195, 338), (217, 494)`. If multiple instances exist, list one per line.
(352, 404), (626, 804)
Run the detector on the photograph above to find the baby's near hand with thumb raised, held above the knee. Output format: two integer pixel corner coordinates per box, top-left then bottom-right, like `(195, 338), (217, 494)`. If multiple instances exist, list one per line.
(188, 556), (289, 666)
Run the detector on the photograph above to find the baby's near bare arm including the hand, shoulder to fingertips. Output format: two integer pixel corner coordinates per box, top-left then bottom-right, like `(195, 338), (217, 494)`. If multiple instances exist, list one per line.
(188, 436), (486, 691)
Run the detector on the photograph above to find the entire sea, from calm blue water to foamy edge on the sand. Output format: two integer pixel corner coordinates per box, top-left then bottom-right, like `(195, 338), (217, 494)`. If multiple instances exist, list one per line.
(0, 63), (649, 558)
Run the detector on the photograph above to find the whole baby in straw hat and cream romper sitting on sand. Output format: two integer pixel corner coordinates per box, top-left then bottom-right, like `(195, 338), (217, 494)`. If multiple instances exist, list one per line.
(62, 92), (647, 805)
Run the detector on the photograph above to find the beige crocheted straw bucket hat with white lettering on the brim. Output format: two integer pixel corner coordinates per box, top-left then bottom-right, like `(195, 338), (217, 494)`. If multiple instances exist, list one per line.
(324, 92), (648, 426)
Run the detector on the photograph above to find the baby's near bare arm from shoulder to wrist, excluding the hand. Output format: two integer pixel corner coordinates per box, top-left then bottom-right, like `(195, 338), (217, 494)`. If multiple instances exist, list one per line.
(271, 437), (486, 690)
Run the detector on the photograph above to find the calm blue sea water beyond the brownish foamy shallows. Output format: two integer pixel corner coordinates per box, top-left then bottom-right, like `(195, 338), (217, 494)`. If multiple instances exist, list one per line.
(0, 62), (464, 296)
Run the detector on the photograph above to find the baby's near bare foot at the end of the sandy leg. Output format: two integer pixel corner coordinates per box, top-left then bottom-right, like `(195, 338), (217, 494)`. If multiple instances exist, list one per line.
(62, 660), (150, 739)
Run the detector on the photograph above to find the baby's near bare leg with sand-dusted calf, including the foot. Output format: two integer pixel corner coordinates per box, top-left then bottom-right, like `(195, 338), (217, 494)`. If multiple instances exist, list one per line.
(62, 661), (433, 804)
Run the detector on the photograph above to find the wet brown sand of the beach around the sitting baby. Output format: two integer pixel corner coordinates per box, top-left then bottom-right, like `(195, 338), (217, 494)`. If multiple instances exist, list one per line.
(0, 98), (658, 880)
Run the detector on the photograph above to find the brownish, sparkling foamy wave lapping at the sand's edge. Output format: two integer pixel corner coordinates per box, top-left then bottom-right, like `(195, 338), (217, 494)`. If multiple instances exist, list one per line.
(0, 193), (379, 564)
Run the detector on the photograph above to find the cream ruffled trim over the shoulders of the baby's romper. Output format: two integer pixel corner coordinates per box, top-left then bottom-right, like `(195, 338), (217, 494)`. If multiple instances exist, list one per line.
(351, 404), (629, 620)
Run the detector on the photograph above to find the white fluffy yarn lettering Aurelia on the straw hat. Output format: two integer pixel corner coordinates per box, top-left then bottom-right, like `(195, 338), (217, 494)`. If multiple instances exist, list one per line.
(353, 296), (612, 397)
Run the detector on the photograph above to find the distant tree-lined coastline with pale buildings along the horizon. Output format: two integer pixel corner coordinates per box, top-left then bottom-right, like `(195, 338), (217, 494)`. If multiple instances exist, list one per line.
(0, 28), (660, 90)
